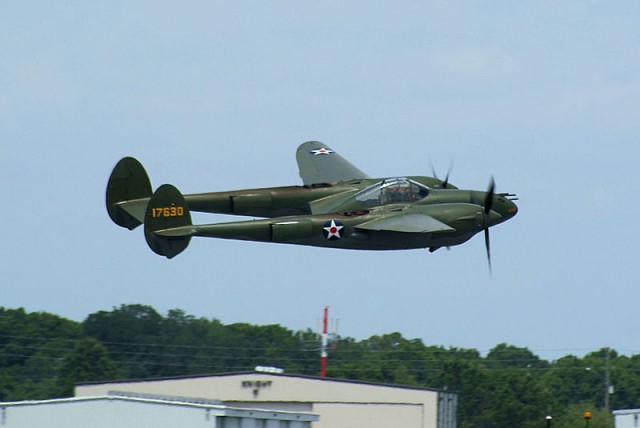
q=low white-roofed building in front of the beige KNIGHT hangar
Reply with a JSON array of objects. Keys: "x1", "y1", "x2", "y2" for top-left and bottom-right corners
[{"x1": 0, "y1": 394, "x2": 318, "y2": 428}]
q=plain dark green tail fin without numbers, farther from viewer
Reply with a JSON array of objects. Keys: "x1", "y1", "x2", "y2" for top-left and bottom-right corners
[{"x1": 106, "y1": 157, "x2": 153, "y2": 230}]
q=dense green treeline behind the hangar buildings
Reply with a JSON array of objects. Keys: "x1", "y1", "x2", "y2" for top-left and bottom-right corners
[{"x1": 0, "y1": 305, "x2": 640, "y2": 428}]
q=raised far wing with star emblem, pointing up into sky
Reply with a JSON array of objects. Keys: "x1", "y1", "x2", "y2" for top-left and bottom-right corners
[{"x1": 296, "y1": 141, "x2": 369, "y2": 185}]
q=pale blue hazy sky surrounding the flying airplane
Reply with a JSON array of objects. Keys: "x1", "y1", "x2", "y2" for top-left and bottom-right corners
[{"x1": 0, "y1": 0, "x2": 640, "y2": 360}]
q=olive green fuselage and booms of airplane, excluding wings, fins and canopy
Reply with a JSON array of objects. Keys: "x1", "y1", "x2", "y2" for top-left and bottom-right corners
[{"x1": 162, "y1": 177, "x2": 517, "y2": 250}]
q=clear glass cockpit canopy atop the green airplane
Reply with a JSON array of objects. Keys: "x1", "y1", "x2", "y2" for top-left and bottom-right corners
[{"x1": 355, "y1": 177, "x2": 430, "y2": 207}]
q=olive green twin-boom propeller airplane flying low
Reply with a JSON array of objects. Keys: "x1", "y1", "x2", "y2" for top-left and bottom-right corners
[{"x1": 106, "y1": 141, "x2": 518, "y2": 268}]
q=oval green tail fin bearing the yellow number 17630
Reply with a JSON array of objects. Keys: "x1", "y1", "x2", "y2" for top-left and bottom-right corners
[{"x1": 144, "y1": 184, "x2": 194, "y2": 259}]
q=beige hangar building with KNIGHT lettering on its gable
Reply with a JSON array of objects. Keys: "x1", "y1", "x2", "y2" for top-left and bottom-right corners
[{"x1": 76, "y1": 372, "x2": 457, "y2": 428}]
